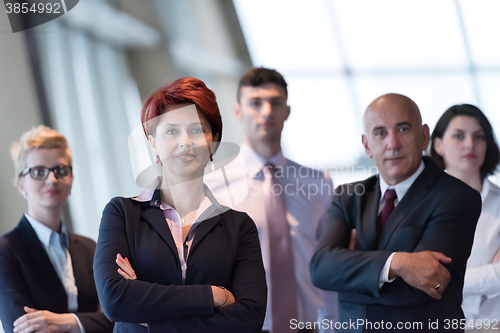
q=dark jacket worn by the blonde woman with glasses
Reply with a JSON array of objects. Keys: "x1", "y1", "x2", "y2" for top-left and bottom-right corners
[{"x1": 0, "y1": 216, "x2": 113, "y2": 333}]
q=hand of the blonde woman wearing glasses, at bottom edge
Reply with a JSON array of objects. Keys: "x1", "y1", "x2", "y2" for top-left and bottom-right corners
[{"x1": 14, "y1": 306, "x2": 80, "y2": 333}]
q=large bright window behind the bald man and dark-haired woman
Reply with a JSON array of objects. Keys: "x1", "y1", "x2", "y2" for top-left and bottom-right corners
[{"x1": 233, "y1": 0, "x2": 500, "y2": 184}]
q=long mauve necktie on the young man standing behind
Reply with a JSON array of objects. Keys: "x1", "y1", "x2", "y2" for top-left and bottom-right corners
[{"x1": 263, "y1": 163, "x2": 298, "y2": 333}]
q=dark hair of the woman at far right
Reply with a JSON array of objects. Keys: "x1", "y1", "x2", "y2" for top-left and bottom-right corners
[{"x1": 431, "y1": 104, "x2": 500, "y2": 180}]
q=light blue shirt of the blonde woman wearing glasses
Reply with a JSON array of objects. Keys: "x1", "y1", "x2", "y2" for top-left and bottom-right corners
[{"x1": 24, "y1": 213, "x2": 85, "y2": 333}]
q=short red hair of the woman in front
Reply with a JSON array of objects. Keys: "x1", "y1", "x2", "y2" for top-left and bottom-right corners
[{"x1": 141, "y1": 77, "x2": 222, "y2": 142}]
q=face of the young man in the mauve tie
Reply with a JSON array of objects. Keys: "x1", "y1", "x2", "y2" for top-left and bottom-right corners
[{"x1": 234, "y1": 83, "x2": 290, "y2": 143}]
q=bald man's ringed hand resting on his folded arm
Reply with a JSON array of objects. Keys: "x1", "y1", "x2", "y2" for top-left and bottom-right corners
[{"x1": 389, "y1": 251, "x2": 451, "y2": 299}]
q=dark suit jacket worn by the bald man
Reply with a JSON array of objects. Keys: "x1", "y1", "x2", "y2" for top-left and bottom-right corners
[{"x1": 310, "y1": 157, "x2": 481, "y2": 332}]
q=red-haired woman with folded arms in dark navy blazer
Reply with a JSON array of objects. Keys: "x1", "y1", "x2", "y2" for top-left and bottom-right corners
[{"x1": 94, "y1": 78, "x2": 267, "y2": 333}]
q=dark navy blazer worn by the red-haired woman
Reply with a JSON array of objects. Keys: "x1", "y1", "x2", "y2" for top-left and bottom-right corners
[{"x1": 94, "y1": 190, "x2": 267, "y2": 333}]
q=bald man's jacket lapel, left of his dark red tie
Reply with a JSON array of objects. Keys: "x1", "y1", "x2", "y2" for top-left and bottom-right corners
[{"x1": 356, "y1": 177, "x2": 380, "y2": 250}]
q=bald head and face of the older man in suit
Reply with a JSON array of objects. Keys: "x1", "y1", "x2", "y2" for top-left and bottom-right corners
[{"x1": 362, "y1": 94, "x2": 429, "y2": 186}]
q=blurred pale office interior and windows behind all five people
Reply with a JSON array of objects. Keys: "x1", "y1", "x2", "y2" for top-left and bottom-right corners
[{"x1": 0, "y1": 0, "x2": 500, "y2": 244}]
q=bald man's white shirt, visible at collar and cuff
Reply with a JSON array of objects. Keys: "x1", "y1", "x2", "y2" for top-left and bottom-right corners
[{"x1": 378, "y1": 162, "x2": 425, "y2": 288}]
